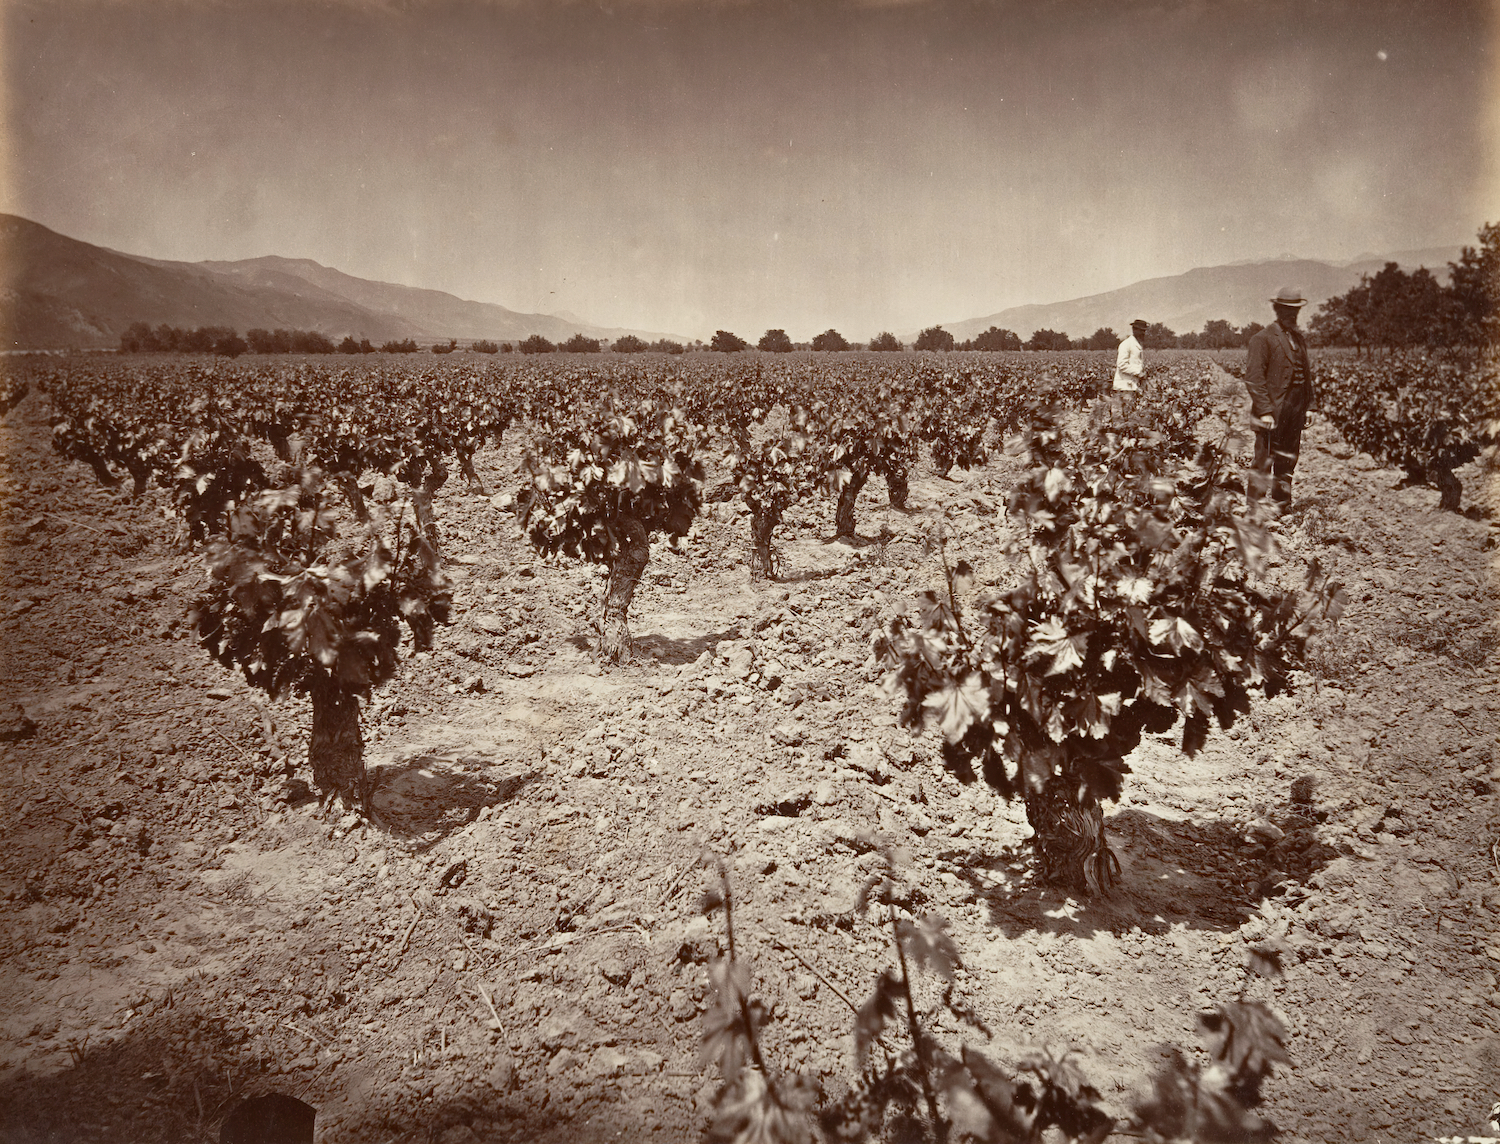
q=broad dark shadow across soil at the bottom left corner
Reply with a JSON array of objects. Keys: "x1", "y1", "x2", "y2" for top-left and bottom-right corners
[{"x1": 0, "y1": 1009, "x2": 663, "y2": 1144}]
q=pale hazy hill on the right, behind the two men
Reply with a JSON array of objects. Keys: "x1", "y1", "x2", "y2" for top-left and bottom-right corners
[{"x1": 936, "y1": 246, "x2": 1461, "y2": 342}]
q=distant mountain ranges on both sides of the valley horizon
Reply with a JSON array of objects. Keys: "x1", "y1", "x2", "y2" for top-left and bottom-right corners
[{"x1": 0, "y1": 214, "x2": 1460, "y2": 349}]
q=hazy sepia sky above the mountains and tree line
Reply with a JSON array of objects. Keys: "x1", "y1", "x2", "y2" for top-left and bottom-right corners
[{"x1": 0, "y1": 0, "x2": 1500, "y2": 340}]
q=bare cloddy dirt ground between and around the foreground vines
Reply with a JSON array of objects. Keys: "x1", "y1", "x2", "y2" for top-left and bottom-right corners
[{"x1": 0, "y1": 382, "x2": 1500, "y2": 1144}]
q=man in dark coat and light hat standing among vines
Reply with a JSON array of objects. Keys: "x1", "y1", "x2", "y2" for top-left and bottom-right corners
[{"x1": 1245, "y1": 286, "x2": 1313, "y2": 508}]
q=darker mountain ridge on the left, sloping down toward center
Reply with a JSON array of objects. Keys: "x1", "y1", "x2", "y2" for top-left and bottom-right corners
[{"x1": 0, "y1": 214, "x2": 684, "y2": 349}]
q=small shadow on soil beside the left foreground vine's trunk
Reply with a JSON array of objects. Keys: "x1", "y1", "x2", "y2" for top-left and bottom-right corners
[{"x1": 371, "y1": 754, "x2": 542, "y2": 850}]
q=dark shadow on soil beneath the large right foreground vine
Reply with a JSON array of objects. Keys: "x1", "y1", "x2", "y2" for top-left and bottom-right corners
[{"x1": 960, "y1": 810, "x2": 1338, "y2": 937}]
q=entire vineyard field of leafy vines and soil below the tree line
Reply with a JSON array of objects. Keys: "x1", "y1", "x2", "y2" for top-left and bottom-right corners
[{"x1": 0, "y1": 351, "x2": 1500, "y2": 1141}]
